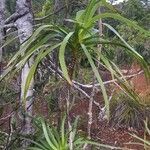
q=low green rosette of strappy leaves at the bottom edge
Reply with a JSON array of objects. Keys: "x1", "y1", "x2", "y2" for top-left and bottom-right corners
[{"x1": 24, "y1": 117, "x2": 121, "y2": 150}]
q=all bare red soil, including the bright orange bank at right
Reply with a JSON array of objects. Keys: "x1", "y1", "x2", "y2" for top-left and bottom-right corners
[{"x1": 0, "y1": 64, "x2": 150, "y2": 150}]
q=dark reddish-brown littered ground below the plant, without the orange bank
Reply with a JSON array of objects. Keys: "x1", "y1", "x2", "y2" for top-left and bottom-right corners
[{"x1": 36, "y1": 94, "x2": 149, "y2": 150}]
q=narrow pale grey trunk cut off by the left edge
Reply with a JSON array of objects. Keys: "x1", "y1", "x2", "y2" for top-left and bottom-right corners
[{"x1": 0, "y1": 0, "x2": 5, "y2": 75}]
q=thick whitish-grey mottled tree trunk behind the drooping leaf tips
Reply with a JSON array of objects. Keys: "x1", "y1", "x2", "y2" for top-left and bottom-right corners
[{"x1": 15, "y1": 0, "x2": 34, "y2": 146}]
